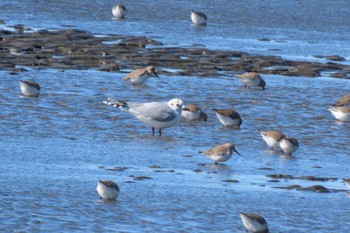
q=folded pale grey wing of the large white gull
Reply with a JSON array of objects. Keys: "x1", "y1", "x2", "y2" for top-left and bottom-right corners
[{"x1": 129, "y1": 102, "x2": 177, "y2": 122}]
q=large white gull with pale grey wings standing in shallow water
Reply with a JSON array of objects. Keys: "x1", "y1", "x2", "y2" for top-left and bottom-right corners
[{"x1": 103, "y1": 98, "x2": 183, "y2": 135}]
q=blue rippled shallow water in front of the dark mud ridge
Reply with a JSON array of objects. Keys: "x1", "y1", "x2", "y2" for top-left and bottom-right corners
[{"x1": 0, "y1": 70, "x2": 350, "y2": 232}]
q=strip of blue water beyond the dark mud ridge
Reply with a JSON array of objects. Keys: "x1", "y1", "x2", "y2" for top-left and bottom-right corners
[{"x1": 0, "y1": 0, "x2": 350, "y2": 59}]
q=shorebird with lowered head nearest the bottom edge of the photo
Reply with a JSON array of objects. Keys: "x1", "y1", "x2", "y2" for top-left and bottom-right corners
[{"x1": 239, "y1": 212, "x2": 269, "y2": 233}]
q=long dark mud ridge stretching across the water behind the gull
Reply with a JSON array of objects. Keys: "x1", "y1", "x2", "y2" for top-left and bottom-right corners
[{"x1": 0, "y1": 25, "x2": 350, "y2": 78}]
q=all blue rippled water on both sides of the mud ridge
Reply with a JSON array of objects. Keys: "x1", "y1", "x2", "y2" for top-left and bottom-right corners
[{"x1": 0, "y1": 0, "x2": 350, "y2": 232}]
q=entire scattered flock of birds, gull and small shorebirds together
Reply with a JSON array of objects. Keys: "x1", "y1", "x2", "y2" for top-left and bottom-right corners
[{"x1": 15, "y1": 4, "x2": 350, "y2": 233}]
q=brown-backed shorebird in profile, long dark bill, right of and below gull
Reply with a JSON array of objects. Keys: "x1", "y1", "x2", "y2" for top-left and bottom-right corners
[{"x1": 199, "y1": 143, "x2": 241, "y2": 164}]
